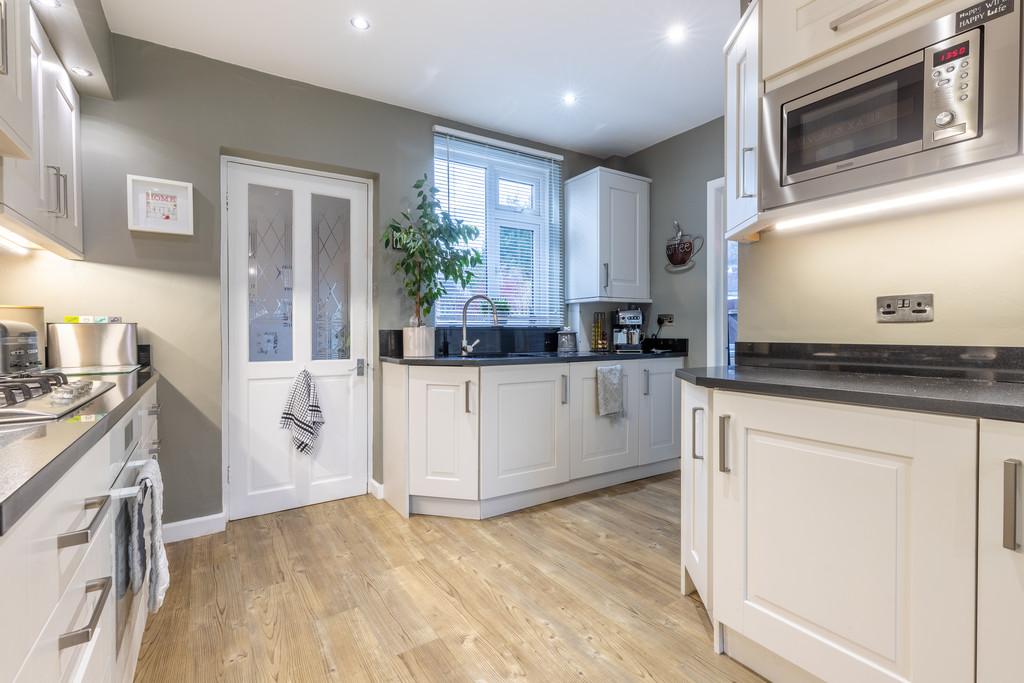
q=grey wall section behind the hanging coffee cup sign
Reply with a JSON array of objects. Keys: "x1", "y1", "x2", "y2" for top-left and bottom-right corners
[{"x1": 625, "y1": 119, "x2": 725, "y2": 367}]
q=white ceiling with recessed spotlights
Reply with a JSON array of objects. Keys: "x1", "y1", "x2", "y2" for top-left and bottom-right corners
[{"x1": 102, "y1": 0, "x2": 739, "y2": 158}]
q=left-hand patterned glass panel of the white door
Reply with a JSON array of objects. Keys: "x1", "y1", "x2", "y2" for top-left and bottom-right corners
[{"x1": 249, "y1": 184, "x2": 293, "y2": 362}]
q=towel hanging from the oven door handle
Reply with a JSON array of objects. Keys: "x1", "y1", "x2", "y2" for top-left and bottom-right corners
[{"x1": 129, "y1": 460, "x2": 171, "y2": 612}]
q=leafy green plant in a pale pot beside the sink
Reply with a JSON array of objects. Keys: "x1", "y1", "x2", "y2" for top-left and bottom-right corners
[{"x1": 383, "y1": 175, "x2": 483, "y2": 358}]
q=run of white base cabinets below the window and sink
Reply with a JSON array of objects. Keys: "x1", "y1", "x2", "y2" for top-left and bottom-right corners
[{"x1": 383, "y1": 357, "x2": 682, "y2": 518}]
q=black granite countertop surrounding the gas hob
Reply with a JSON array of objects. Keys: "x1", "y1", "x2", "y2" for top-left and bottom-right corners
[{"x1": 0, "y1": 368, "x2": 160, "y2": 536}]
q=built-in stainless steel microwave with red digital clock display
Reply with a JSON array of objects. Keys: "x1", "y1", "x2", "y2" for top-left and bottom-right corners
[{"x1": 759, "y1": 0, "x2": 1022, "y2": 210}]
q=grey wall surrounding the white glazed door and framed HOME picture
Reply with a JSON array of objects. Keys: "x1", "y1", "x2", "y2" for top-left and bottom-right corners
[{"x1": 0, "y1": 36, "x2": 598, "y2": 521}]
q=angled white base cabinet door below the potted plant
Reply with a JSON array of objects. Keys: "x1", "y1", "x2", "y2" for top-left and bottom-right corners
[{"x1": 409, "y1": 367, "x2": 480, "y2": 501}]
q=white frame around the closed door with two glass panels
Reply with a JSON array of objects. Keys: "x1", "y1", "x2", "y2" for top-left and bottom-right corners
[{"x1": 220, "y1": 155, "x2": 377, "y2": 523}]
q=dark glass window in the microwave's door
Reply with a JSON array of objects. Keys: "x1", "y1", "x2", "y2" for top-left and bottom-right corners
[{"x1": 785, "y1": 63, "x2": 924, "y2": 177}]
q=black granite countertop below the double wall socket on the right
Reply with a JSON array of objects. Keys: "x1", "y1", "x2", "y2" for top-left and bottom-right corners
[{"x1": 676, "y1": 366, "x2": 1024, "y2": 422}]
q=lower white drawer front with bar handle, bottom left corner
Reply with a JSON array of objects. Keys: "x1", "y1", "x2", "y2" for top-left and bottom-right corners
[{"x1": 15, "y1": 511, "x2": 116, "y2": 683}]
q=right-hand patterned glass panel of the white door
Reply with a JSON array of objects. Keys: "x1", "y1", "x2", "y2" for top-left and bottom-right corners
[{"x1": 312, "y1": 195, "x2": 352, "y2": 360}]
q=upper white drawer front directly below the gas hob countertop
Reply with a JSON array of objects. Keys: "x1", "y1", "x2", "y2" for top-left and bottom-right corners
[{"x1": 0, "y1": 435, "x2": 113, "y2": 681}]
